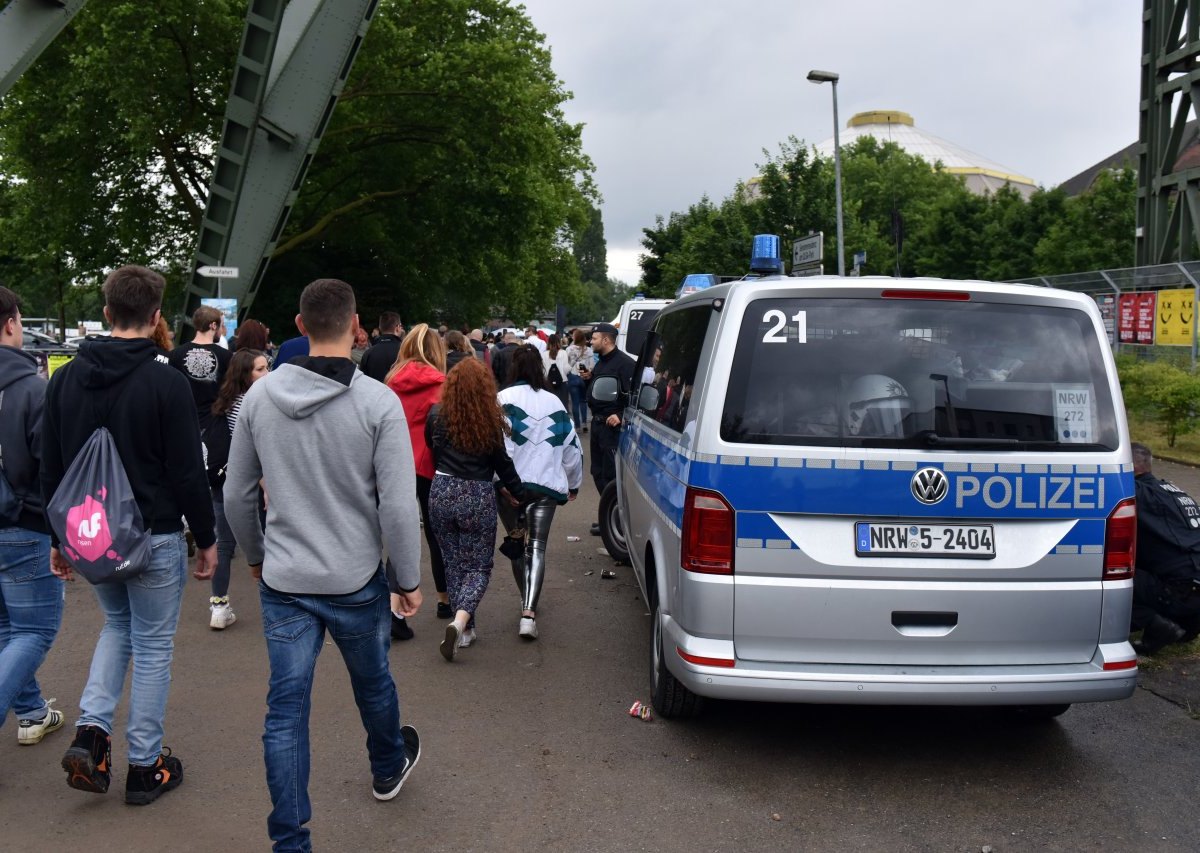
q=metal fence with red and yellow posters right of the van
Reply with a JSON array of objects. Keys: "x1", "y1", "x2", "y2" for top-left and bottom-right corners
[{"x1": 1016, "y1": 260, "x2": 1200, "y2": 368}]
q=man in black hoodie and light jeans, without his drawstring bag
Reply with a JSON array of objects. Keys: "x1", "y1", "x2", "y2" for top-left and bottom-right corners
[{"x1": 42, "y1": 266, "x2": 216, "y2": 805}]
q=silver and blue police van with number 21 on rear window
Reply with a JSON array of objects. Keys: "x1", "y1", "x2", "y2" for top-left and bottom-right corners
[{"x1": 592, "y1": 243, "x2": 1138, "y2": 717}]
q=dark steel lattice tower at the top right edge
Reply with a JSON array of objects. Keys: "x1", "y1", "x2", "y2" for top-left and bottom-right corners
[{"x1": 1136, "y1": 0, "x2": 1200, "y2": 266}]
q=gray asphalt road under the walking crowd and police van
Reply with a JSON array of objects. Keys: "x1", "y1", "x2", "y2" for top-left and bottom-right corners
[{"x1": 0, "y1": 453, "x2": 1200, "y2": 852}]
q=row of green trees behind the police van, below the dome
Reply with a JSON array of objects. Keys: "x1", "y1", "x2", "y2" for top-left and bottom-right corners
[{"x1": 641, "y1": 137, "x2": 1136, "y2": 290}]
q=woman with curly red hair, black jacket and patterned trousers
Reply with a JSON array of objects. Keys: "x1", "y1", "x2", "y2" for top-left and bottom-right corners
[{"x1": 425, "y1": 359, "x2": 523, "y2": 661}]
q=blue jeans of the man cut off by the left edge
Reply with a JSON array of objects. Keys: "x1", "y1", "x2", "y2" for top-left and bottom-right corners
[{"x1": 0, "y1": 527, "x2": 62, "y2": 725}]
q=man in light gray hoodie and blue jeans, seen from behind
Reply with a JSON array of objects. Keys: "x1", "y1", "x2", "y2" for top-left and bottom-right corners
[{"x1": 224, "y1": 278, "x2": 421, "y2": 851}]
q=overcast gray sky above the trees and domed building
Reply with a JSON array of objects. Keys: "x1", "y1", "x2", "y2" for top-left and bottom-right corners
[{"x1": 523, "y1": 0, "x2": 1141, "y2": 283}]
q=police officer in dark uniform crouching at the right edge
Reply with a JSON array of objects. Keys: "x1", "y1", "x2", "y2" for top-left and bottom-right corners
[{"x1": 1132, "y1": 444, "x2": 1200, "y2": 655}]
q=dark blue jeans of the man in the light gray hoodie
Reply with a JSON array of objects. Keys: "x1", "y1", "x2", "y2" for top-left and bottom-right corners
[{"x1": 258, "y1": 566, "x2": 404, "y2": 851}]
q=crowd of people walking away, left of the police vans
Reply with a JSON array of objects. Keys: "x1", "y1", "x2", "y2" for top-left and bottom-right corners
[{"x1": 0, "y1": 272, "x2": 592, "y2": 851}]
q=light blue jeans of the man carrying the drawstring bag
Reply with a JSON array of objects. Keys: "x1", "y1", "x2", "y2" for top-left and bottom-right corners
[{"x1": 76, "y1": 533, "x2": 187, "y2": 764}]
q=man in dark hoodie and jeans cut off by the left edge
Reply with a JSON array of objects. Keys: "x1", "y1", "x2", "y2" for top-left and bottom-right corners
[{"x1": 0, "y1": 287, "x2": 64, "y2": 744}]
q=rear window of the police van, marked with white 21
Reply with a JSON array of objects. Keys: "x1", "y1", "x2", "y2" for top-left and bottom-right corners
[{"x1": 721, "y1": 298, "x2": 1117, "y2": 451}]
